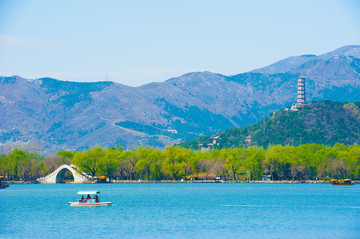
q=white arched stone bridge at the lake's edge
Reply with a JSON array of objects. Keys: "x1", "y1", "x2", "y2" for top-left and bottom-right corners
[{"x1": 36, "y1": 164, "x2": 90, "y2": 183}]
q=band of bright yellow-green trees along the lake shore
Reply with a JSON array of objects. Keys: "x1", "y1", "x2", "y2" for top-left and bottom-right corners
[{"x1": 0, "y1": 143, "x2": 360, "y2": 181}]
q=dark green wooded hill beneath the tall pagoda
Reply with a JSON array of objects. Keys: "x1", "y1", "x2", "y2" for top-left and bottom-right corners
[{"x1": 181, "y1": 101, "x2": 360, "y2": 149}]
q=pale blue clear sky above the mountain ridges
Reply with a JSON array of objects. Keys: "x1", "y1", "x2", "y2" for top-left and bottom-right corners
[{"x1": 0, "y1": 0, "x2": 360, "y2": 86}]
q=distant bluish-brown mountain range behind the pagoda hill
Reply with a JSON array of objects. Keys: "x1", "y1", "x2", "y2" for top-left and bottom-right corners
[{"x1": 0, "y1": 46, "x2": 360, "y2": 153}]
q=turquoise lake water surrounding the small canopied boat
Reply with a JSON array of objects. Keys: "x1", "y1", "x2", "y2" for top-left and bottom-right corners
[{"x1": 0, "y1": 183, "x2": 360, "y2": 239}]
